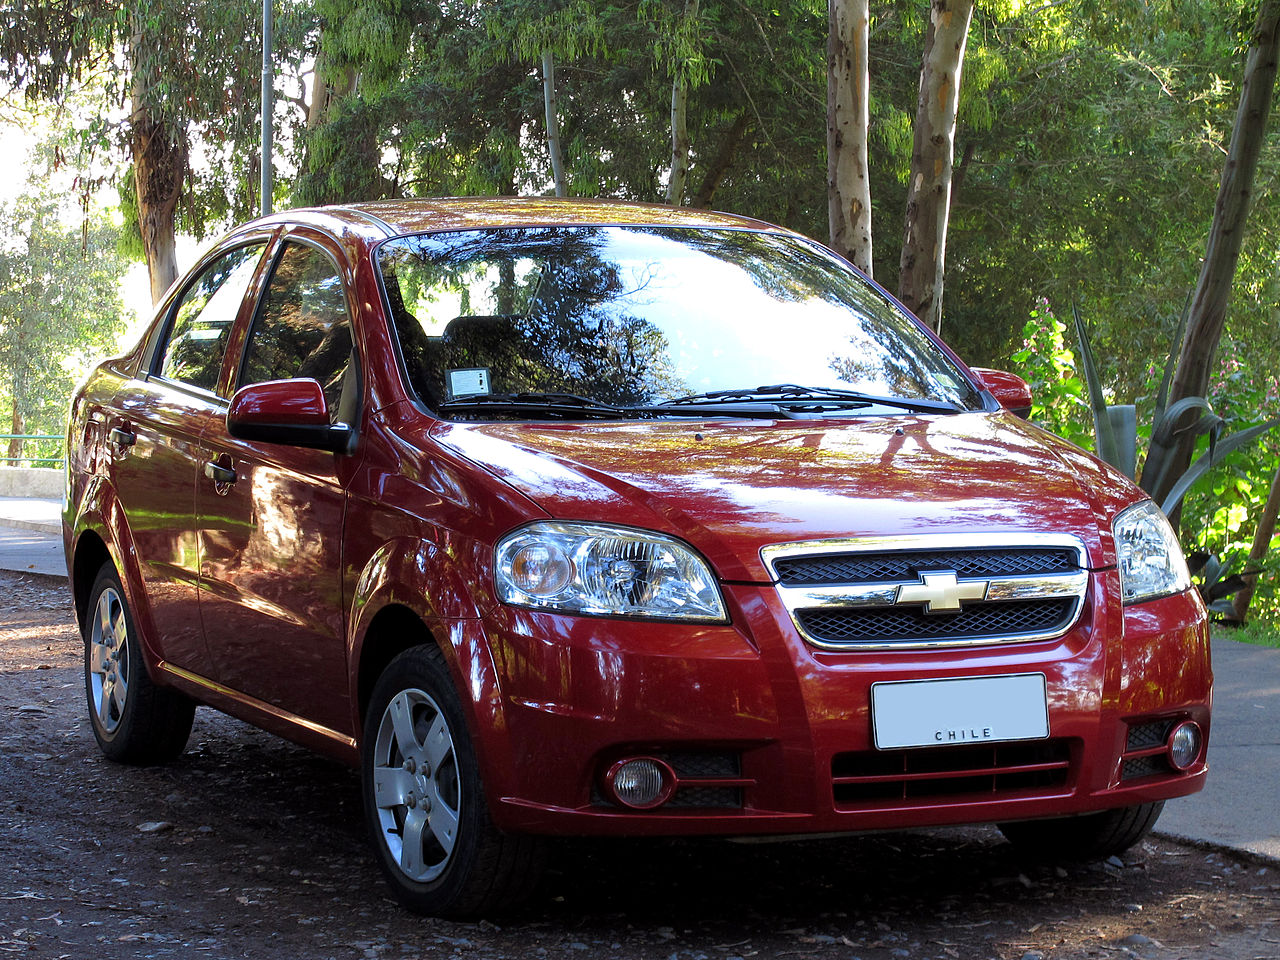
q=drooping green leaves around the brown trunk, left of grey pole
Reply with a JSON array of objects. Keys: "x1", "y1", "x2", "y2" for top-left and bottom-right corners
[{"x1": 0, "y1": 0, "x2": 312, "y2": 237}]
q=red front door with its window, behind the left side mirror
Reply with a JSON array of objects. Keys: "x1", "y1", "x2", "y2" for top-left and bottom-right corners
[{"x1": 196, "y1": 232, "x2": 361, "y2": 736}]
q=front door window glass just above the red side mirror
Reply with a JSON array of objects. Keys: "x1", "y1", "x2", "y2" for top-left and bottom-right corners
[{"x1": 241, "y1": 243, "x2": 353, "y2": 419}]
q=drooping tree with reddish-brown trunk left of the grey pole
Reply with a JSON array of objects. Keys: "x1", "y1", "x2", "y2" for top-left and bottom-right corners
[{"x1": 0, "y1": 0, "x2": 309, "y2": 301}]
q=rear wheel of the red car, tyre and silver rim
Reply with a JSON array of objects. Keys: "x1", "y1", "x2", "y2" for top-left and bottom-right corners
[{"x1": 81, "y1": 563, "x2": 196, "y2": 765}]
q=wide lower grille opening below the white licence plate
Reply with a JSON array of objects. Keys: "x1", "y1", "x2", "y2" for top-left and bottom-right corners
[{"x1": 831, "y1": 740, "x2": 1071, "y2": 808}]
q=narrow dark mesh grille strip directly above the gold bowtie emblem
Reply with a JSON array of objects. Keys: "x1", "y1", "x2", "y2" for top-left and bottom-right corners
[{"x1": 773, "y1": 548, "x2": 1080, "y2": 585}]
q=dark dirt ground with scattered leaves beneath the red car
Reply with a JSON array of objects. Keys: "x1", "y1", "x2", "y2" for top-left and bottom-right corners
[{"x1": 0, "y1": 573, "x2": 1280, "y2": 960}]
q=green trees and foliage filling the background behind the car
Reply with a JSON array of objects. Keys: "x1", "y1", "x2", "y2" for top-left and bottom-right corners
[{"x1": 0, "y1": 0, "x2": 1280, "y2": 620}]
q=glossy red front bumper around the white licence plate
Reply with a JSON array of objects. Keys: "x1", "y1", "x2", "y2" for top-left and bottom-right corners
[{"x1": 454, "y1": 571, "x2": 1212, "y2": 836}]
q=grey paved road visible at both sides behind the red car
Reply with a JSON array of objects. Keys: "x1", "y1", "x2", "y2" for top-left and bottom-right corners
[{"x1": 0, "y1": 497, "x2": 1280, "y2": 860}]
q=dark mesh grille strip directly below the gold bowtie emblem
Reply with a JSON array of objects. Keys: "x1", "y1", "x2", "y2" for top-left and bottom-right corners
[{"x1": 799, "y1": 600, "x2": 1075, "y2": 644}]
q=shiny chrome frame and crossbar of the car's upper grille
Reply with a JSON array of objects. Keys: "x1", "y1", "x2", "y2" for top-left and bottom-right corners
[{"x1": 760, "y1": 534, "x2": 1089, "y2": 650}]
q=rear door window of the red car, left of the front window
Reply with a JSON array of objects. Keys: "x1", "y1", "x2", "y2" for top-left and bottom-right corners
[{"x1": 160, "y1": 243, "x2": 264, "y2": 392}]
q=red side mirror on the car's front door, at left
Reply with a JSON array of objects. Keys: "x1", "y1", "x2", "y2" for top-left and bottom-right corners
[{"x1": 227, "y1": 378, "x2": 353, "y2": 453}]
